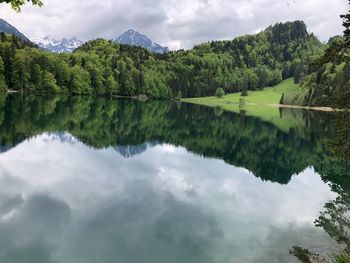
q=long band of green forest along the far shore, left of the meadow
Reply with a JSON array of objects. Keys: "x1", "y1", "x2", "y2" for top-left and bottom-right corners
[{"x1": 0, "y1": 21, "x2": 322, "y2": 98}]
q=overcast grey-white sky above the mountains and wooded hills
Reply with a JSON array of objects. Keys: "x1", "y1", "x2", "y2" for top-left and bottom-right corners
[{"x1": 0, "y1": 0, "x2": 348, "y2": 49}]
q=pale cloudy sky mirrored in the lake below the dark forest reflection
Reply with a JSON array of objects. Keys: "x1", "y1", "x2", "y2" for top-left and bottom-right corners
[{"x1": 0, "y1": 136, "x2": 334, "y2": 263}]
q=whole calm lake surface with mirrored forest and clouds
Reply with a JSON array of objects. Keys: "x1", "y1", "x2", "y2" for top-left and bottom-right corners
[{"x1": 0, "y1": 95, "x2": 350, "y2": 263}]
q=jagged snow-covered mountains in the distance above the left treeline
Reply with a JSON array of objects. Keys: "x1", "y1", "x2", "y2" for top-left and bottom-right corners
[{"x1": 31, "y1": 36, "x2": 83, "y2": 53}]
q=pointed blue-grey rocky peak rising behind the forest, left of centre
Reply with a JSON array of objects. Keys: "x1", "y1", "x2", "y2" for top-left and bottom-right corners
[{"x1": 113, "y1": 29, "x2": 169, "y2": 53}]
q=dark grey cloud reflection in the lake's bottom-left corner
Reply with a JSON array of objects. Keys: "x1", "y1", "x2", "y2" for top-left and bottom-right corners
[{"x1": 0, "y1": 194, "x2": 70, "y2": 263}]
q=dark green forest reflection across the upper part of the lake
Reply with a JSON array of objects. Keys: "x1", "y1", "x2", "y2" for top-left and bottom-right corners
[{"x1": 0, "y1": 95, "x2": 350, "y2": 262}]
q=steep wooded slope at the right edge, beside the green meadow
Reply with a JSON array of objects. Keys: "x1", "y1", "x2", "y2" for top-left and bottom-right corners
[{"x1": 283, "y1": 1, "x2": 350, "y2": 108}]
